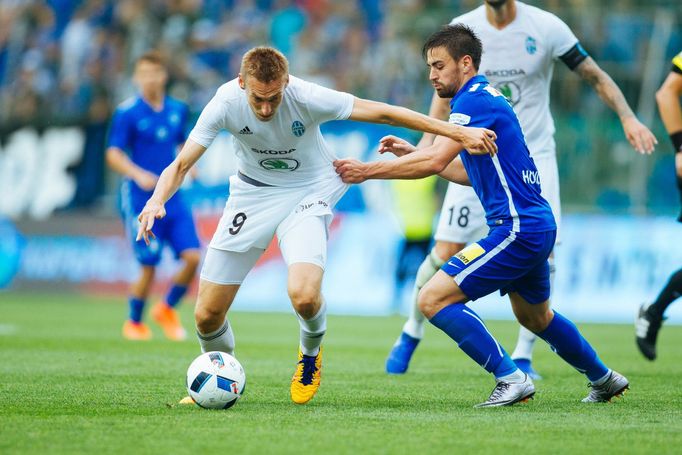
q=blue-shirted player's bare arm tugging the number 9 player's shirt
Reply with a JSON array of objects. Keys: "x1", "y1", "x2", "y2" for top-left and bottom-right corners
[{"x1": 334, "y1": 137, "x2": 463, "y2": 183}]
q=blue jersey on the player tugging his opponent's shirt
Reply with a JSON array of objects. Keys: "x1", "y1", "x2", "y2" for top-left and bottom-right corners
[{"x1": 450, "y1": 75, "x2": 556, "y2": 232}]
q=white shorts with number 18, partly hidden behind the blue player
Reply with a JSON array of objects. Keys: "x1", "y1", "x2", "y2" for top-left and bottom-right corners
[{"x1": 434, "y1": 154, "x2": 561, "y2": 244}]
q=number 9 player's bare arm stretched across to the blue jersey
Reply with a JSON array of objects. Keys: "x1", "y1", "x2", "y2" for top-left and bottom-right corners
[{"x1": 349, "y1": 98, "x2": 497, "y2": 154}]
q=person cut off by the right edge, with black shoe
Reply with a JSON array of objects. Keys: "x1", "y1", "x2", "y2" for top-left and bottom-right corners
[{"x1": 635, "y1": 52, "x2": 682, "y2": 360}]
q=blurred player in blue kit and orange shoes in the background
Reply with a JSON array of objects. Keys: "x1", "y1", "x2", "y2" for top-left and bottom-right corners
[{"x1": 106, "y1": 51, "x2": 201, "y2": 341}]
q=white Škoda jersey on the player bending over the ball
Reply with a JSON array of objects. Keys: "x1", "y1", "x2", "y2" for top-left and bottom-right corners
[{"x1": 189, "y1": 76, "x2": 354, "y2": 187}]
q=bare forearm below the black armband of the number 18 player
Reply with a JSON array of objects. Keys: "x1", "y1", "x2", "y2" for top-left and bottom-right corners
[{"x1": 576, "y1": 57, "x2": 658, "y2": 154}]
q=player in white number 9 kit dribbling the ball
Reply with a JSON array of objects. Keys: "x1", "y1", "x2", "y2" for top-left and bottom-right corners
[{"x1": 138, "y1": 47, "x2": 496, "y2": 404}]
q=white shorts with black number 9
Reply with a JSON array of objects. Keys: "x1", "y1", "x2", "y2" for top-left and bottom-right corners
[{"x1": 201, "y1": 176, "x2": 348, "y2": 284}]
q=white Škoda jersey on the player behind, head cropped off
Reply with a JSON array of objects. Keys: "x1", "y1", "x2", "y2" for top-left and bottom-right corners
[{"x1": 451, "y1": 1, "x2": 578, "y2": 157}]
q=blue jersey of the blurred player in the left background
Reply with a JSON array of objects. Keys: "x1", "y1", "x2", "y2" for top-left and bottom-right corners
[{"x1": 108, "y1": 96, "x2": 189, "y2": 213}]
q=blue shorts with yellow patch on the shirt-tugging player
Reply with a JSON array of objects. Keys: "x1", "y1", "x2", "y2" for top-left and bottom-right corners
[{"x1": 441, "y1": 228, "x2": 556, "y2": 304}]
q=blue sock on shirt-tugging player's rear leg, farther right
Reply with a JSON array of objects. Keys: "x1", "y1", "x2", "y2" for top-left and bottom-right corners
[{"x1": 536, "y1": 311, "x2": 609, "y2": 382}]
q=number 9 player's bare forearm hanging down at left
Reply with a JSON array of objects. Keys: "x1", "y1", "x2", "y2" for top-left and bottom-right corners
[{"x1": 137, "y1": 139, "x2": 206, "y2": 245}]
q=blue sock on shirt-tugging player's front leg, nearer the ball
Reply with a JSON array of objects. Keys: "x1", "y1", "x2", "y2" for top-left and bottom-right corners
[{"x1": 430, "y1": 303, "x2": 517, "y2": 378}]
